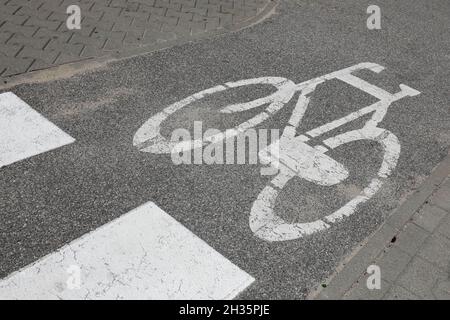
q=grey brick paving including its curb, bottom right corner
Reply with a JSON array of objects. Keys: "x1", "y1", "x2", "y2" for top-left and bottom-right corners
[{"x1": 309, "y1": 151, "x2": 450, "y2": 300}]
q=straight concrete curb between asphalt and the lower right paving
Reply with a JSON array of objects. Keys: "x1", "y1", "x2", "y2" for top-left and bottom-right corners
[{"x1": 308, "y1": 153, "x2": 450, "y2": 300}]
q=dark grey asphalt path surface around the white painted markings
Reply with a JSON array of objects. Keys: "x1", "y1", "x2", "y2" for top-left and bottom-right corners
[{"x1": 0, "y1": 0, "x2": 450, "y2": 299}]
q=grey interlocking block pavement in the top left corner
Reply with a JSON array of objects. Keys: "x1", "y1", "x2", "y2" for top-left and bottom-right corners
[{"x1": 0, "y1": 0, "x2": 275, "y2": 77}]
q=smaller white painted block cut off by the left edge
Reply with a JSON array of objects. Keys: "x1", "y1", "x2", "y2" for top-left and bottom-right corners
[{"x1": 0, "y1": 92, "x2": 75, "y2": 168}]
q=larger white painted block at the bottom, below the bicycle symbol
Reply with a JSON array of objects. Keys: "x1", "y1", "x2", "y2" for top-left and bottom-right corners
[{"x1": 0, "y1": 202, "x2": 254, "y2": 299}]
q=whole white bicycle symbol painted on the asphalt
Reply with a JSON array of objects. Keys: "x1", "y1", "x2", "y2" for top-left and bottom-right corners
[{"x1": 133, "y1": 63, "x2": 420, "y2": 241}]
